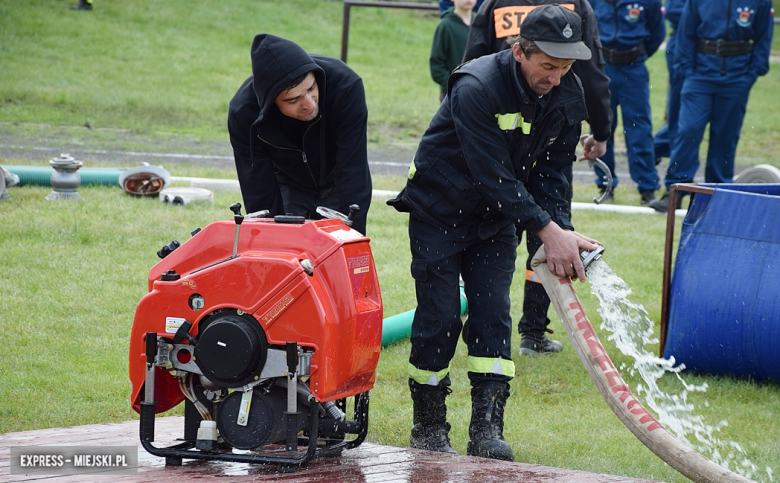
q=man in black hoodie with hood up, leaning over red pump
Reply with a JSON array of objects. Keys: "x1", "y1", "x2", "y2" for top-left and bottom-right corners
[{"x1": 228, "y1": 34, "x2": 371, "y2": 234}]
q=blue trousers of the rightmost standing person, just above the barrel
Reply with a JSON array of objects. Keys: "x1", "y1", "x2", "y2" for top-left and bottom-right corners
[{"x1": 664, "y1": 77, "x2": 755, "y2": 189}]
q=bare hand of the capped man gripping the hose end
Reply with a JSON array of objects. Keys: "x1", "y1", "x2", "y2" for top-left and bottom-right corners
[{"x1": 536, "y1": 222, "x2": 601, "y2": 282}]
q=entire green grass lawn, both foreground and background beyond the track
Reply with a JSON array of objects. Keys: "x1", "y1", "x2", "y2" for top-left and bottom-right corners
[{"x1": 0, "y1": 0, "x2": 780, "y2": 482}]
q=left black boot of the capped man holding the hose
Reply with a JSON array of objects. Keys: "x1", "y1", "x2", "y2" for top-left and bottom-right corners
[{"x1": 409, "y1": 379, "x2": 458, "y2": 454}]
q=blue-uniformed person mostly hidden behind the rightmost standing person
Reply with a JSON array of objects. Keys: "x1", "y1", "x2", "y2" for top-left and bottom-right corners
[{"x1": 653, "y1": 0, "x2": 685, "y2": 165}]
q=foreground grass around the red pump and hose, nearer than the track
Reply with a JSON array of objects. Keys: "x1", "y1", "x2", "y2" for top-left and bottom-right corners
[{"x1": 0, "y1": 173, "x2": 780, "y2": 482}]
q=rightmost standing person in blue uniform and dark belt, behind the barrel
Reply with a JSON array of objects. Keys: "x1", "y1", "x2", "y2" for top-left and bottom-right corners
[{"x1": 650, "y1": 0, "x2": 774, "y2": 213}]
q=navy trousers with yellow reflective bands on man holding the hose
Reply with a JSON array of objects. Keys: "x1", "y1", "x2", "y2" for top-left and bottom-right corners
[{"x1": 409, "y1": 213, "x2": 517, "y2": 385}]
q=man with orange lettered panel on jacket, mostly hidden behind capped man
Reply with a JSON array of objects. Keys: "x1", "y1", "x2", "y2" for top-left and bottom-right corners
[{"x1": 463, "y1": 0, "x2": 612, "y2": 356}]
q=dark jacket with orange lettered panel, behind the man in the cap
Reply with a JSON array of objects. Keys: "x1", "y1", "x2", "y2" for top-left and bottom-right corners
[{"x1": 463, "y1": 0, "x2": 612, "y2": 141}]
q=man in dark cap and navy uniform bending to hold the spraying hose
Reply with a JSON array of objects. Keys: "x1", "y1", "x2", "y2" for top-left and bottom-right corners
[{"x1": 388, "y1": 5, "x2": 597, "y2": 460}]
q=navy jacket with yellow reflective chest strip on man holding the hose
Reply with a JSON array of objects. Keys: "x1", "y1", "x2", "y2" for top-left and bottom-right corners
[{"x1": 388, "y1": 50, "x2": 587, "y2": 239}]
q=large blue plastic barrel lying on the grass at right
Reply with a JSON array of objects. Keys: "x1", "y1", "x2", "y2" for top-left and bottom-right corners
[{"x1": 663, "y1": 184, "x2": 780, "y2": 382}]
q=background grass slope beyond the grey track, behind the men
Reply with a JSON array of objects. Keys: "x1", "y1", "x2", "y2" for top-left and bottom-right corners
[{"x1": 0, "y1": 0, "x2": 780, "y2": 167}]
